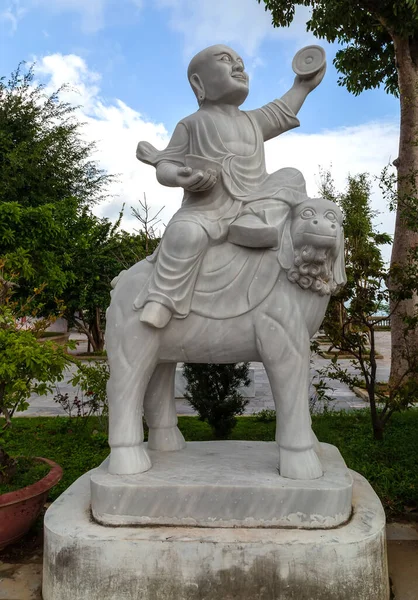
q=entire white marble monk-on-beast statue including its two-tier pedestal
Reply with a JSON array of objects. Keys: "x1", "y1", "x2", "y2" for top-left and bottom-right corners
[{"x1": 42, "y1": 45, "x2": 390, "y2": 600}]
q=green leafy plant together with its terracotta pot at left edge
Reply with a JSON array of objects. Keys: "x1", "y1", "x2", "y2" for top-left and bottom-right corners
[{"x1": 0, "y1": 263, "x2": 69, "y2": 549}]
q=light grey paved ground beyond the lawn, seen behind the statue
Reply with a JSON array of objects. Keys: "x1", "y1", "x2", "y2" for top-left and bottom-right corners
[{"x1": 21, "y1": 331, "x2": 390, "y2": 418}]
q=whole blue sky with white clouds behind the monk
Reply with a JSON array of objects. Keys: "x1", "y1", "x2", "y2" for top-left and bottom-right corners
[{"x1": 0, "y1": 0, "x2": 399, "y2": 246}]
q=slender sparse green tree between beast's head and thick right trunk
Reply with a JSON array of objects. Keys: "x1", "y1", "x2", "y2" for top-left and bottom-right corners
[{"x1": 321, "y1": 173, "x2": 418, "y2": 440}]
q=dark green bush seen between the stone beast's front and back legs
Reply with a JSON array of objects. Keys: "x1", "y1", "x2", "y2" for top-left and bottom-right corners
[{"x1": 183, "y1": 363, "x2": 250, "y2": 439}]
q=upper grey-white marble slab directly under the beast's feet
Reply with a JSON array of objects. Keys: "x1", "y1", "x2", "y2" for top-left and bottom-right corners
[{"x1": 91, "y1": 441, "x2": 353, "y2": 529}]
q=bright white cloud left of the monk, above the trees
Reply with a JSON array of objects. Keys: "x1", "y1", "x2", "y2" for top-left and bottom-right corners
[{"x1": 36, "y1": 54, "x2": 181, "y2": 230}]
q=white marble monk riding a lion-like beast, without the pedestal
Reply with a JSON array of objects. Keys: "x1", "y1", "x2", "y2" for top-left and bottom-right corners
[{"x1": 106, "y1": 45, "x2": 345, "y2": 480}]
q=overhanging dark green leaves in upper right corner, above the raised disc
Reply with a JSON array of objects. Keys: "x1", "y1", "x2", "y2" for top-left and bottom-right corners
[{"x1": 258, "y1": 0, "x2": 418, "y2": 95}]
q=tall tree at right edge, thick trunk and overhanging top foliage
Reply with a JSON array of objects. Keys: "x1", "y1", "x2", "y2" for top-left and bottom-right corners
[{"x1": 258, "y1": 0, "x2": 418, "y2": 385}]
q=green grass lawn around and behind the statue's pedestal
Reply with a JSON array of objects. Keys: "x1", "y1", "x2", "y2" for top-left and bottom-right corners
[{"x1": 2, "y1": 409, "x2": 418, "y2": 518}]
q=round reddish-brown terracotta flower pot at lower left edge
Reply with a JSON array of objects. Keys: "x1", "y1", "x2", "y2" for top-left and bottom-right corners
[{"x1": 0, "y1": 458, "x2": 62, "y2": 550}]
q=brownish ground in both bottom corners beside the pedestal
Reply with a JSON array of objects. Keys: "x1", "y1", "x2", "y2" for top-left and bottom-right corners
[{"x1": 0, "y1": 523, "x2": 418, "y2": 600}]
